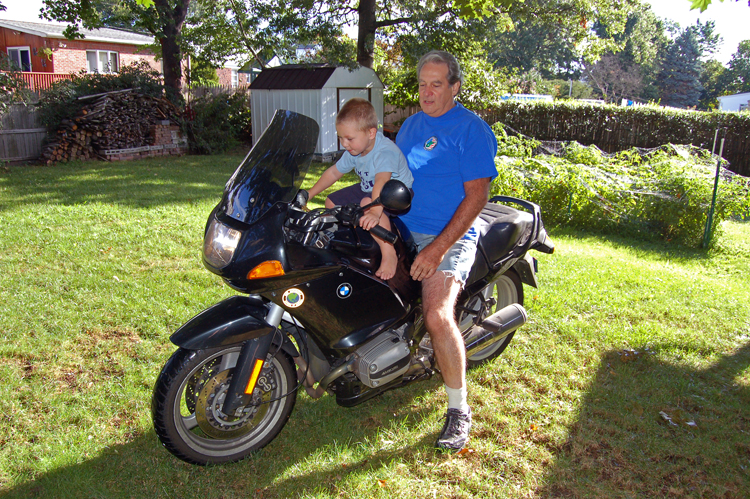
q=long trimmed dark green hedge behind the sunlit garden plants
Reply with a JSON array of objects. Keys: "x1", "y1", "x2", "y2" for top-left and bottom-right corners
[{"x1": 481, "y1": 101, "x2": 750, "y2": 176}]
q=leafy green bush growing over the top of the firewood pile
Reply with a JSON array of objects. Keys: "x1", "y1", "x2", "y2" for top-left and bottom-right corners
[{"x1": 37, "y1": 61, "x2": 164, "y2": 130}]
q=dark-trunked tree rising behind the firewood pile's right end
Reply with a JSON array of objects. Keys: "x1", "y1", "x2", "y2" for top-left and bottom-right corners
[{"x1": 42, "y1": 0, "x2": 190, "y2": 97}]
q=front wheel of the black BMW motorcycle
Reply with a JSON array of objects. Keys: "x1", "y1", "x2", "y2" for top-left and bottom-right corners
[{"x1": 151, "y1": 345, "x2": 297, "y2": 465}]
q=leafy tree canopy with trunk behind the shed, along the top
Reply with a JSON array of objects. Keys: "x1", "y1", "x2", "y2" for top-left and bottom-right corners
[{"x1": 185, "y1": 0, "x2": 637, "y2": 73}]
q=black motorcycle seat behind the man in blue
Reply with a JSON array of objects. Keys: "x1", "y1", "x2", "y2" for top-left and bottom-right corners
[{"x1": 477, "y1": 203, "x2": 534, "y2": 268}]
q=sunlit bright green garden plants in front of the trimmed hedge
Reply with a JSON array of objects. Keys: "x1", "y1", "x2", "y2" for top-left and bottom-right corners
[{"x1": 492, "y1": 133, "x2": 750, "y2": 247}]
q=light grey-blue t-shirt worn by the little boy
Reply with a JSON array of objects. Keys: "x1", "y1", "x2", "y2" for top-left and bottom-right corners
[{"x1": 336, "y1": 132, "x2": 414, "y2": 192}]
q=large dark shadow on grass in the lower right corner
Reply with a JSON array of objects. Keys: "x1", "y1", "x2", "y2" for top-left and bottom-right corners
[{"x1": 538, "y1": 344, "x2": 750, "y2": 498}]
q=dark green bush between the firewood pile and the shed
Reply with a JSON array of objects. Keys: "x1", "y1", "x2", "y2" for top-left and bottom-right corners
[{"x1": 184, "y1": 89, "x2": 251, "y2": 154}]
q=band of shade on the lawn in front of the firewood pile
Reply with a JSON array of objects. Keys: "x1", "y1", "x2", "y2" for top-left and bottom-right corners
[{"x1": 0, "y1": 156, "x2": 242, "y2": 211}]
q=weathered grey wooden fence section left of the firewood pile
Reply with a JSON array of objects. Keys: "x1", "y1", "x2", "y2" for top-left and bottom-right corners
[{"x1": 0, "y1": 106, "x2": 47, "y2": 161}]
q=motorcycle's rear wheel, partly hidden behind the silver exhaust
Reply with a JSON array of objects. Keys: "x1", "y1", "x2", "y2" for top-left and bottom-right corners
[{"x1": 458, "y1": 270, "x2": 523, "y2": 368}]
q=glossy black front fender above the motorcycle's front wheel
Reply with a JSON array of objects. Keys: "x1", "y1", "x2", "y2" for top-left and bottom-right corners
[{"x1": 169, "y1": 296, "x2": 276, "y2": 350}]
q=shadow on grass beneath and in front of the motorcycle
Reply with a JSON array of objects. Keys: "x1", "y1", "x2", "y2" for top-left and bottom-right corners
[{"x1": 3, "y1": 379, "x2": 438, "y2": 499}]
